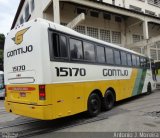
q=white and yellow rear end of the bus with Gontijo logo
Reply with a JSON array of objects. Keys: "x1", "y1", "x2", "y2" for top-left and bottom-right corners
[{"x1": 4, "y1": 20, "x2": 53, "y2": 120}]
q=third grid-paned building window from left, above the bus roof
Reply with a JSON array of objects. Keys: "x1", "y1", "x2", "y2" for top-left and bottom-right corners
[{"x1": 100, "y1": 29, "x2": 111, "y2": 42}]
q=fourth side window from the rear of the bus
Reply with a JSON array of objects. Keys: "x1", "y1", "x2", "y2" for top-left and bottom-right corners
[{"x1": 96, "y1": 46, "x2": 105, "y2": 63}]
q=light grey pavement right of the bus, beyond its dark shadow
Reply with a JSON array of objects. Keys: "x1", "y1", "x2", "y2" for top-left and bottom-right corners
[{"x1": 33, "y1": 90, "x2": 160, "y2": 138}]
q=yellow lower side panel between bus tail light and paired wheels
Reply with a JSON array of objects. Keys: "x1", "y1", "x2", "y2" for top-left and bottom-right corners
[{"x1": 48, "y1": 83, "x2": 85, "y2": 118}]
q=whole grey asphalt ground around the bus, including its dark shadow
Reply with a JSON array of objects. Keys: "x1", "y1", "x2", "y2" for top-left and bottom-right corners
[{"x1": 0, "y1": 90, "x2": 160, "y2": 138}]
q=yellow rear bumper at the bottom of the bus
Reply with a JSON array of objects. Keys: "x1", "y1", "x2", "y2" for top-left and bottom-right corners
[{"x1": 5, "y1": 101, "x2": 54, "y2": 120}]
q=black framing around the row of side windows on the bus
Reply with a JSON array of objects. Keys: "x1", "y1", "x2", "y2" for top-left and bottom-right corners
[{"x1": 48, "y1": 28, "x2": 149, "y2": 69}]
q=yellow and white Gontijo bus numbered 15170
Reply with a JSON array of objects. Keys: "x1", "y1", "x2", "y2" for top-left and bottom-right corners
[{"x1": 4, "y1": 19, "x2": 154, "y2": 120}]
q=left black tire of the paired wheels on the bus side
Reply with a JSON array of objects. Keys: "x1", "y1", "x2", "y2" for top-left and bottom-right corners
[{"x1": 87, "y1": 93, "x2": 101, "y2": 117}]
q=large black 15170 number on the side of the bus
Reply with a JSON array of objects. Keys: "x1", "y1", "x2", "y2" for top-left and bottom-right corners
[{"x1": 55, "y1": 67, "x2": 86, "y2": 77}]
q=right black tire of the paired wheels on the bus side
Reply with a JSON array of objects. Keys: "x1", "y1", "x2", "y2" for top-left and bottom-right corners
[{"x1": 102, "y1": 90, "x2": 115, "y2": 111}]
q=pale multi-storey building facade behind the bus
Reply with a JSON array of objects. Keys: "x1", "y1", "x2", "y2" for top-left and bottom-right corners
[{"x1": 12, "y1": 0, "x2": 160, "y2": 61}]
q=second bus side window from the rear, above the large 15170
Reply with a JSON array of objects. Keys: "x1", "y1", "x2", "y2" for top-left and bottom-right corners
[{"x1": 70, "y1": 39, "x2": 83, "y2": 59}]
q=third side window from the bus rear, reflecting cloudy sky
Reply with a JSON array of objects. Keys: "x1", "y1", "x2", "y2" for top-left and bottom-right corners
[{"x1": 83, "y1": 42, "x2": 95, "y2": 61}]
